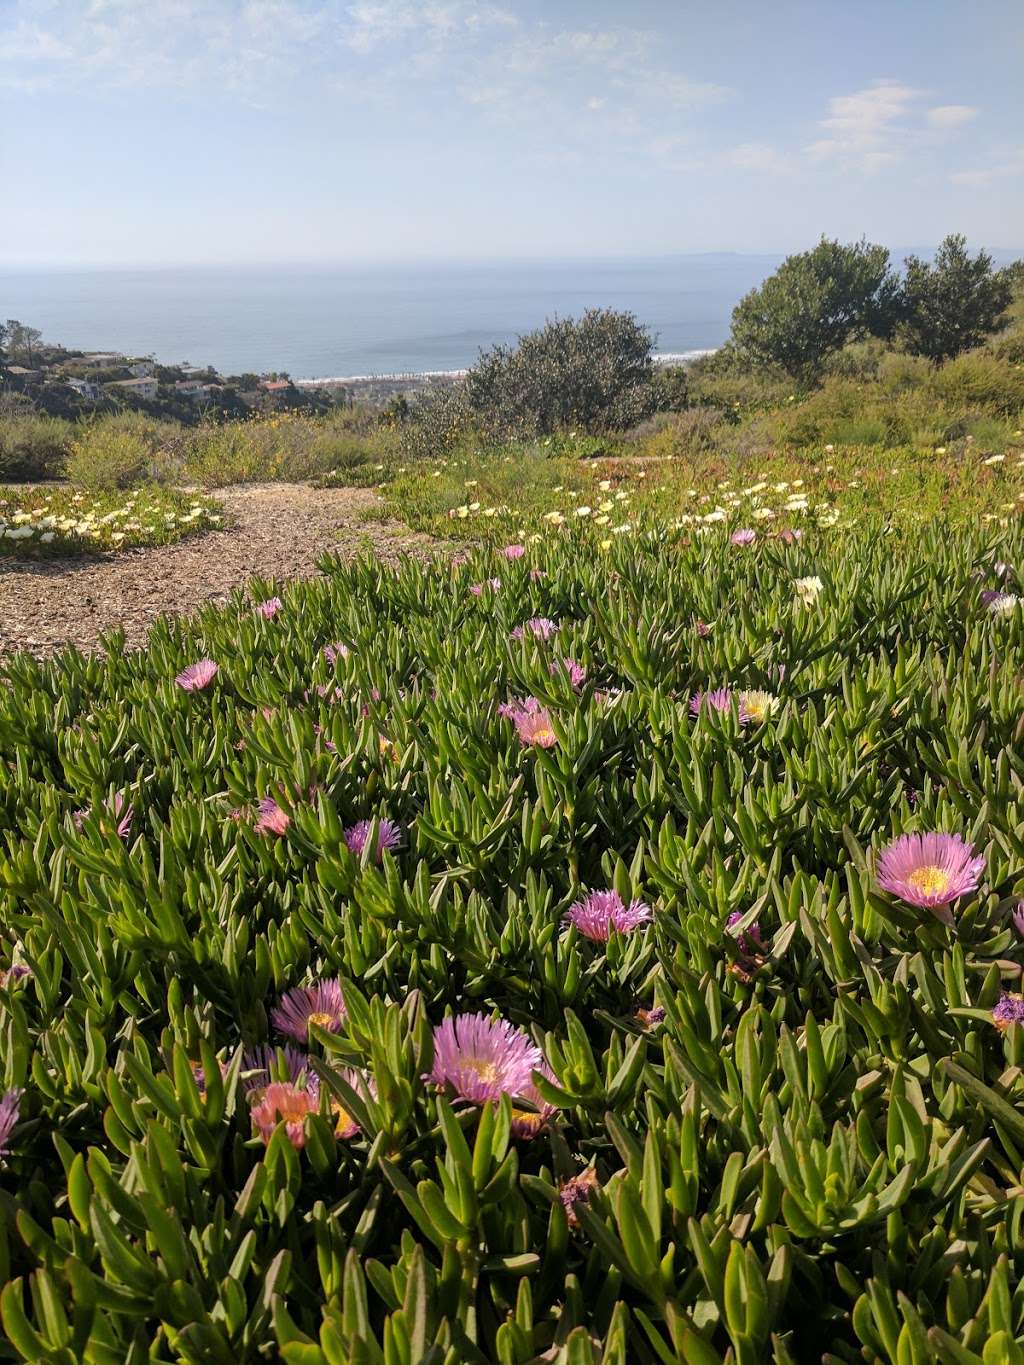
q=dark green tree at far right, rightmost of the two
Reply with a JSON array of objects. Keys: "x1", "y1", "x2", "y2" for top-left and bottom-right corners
[{"x1": 898, "y1": 233, "x2": 1014, "y2": 364}]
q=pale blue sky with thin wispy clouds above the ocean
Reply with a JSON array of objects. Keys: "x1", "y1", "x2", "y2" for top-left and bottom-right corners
[{"x1": 0, "y1": 0, "x2": 1024, "y2": 265}]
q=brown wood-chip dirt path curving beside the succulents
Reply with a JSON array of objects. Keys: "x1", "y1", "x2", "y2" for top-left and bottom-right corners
[{"x1": 0, "y1": 483, "x2": 430, "y2": 657}]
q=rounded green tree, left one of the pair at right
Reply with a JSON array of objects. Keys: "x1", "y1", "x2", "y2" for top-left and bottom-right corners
[{"x1": 732, "y1": 238, "x2": 898, "y2": 379}]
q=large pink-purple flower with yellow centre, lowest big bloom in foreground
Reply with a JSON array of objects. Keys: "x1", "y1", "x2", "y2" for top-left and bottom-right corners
[{"x1": 427, "y1": 1014, "x2": 545, "y2": 1104}]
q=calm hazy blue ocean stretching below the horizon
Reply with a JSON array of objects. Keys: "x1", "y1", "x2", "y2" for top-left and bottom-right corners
[{"x1": 0, "y1": 255, "x2": 780, "y2": 378}]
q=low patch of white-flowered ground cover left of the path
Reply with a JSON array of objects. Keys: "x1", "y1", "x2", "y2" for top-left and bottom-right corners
[{"x1": 0, "y1": 485, "x2": 221, "y2": 558}]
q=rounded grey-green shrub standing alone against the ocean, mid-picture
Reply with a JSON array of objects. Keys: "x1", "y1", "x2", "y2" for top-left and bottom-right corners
[{"x1": 466, "y1": 308, "x2": 658, "y2": 438}]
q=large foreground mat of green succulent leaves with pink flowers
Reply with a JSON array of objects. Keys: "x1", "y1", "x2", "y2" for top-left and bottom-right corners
[{"x1": 0, "y1": 517, "x2": 1024, "y2": 1365}]
